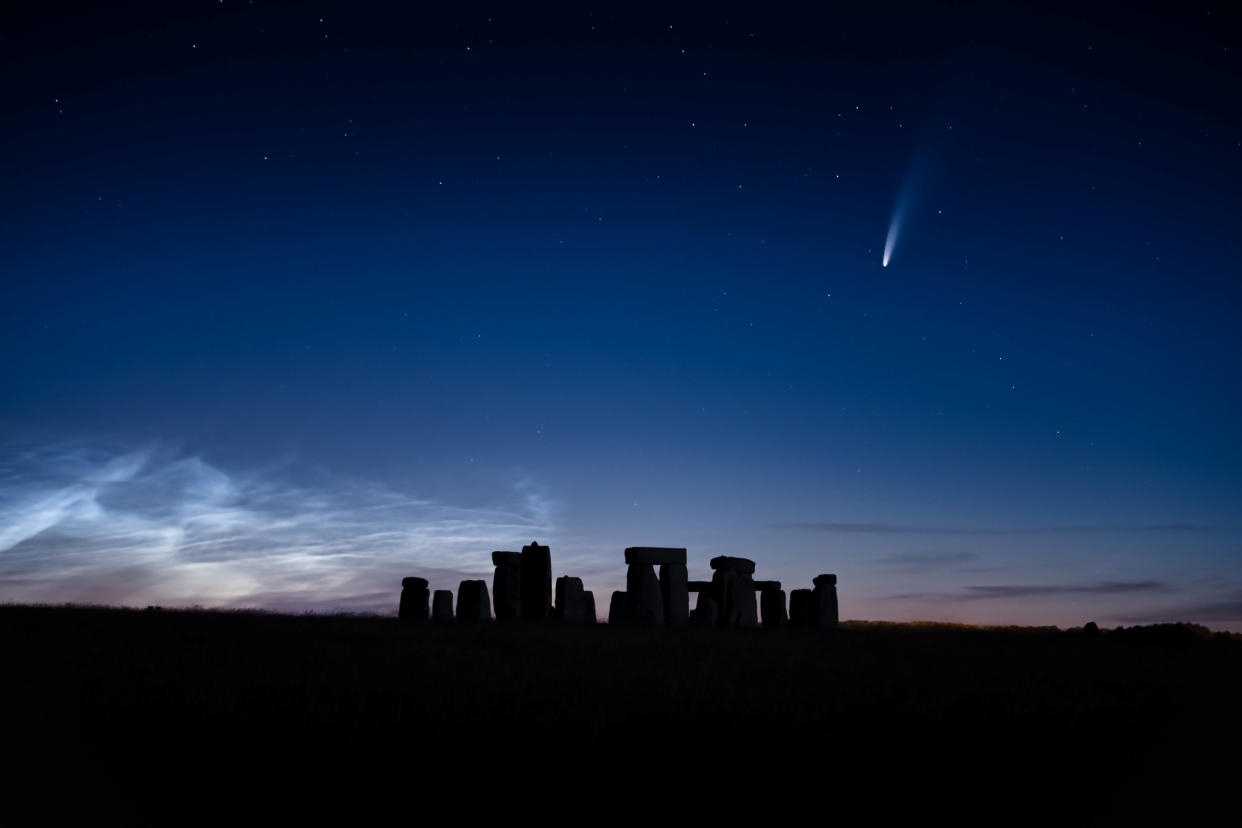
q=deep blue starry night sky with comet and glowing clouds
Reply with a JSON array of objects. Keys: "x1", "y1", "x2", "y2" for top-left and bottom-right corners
[{"x1": 0, "y1": 0, "x2": 1242, "y2": 629}]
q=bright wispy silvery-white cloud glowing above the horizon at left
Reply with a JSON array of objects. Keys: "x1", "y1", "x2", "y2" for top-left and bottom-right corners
[{"x1": 0, "y1": 446, "x2": 555, "y2": 610}]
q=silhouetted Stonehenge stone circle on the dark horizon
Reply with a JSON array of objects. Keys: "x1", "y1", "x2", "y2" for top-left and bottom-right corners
[{"x1": 397, "y1": 541, "x2": 840, "y2": 629}]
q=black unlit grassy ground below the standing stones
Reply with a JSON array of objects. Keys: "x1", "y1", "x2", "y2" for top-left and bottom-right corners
[{"x1": 0, "y1": 606, "x2": 1242, "y2": 824}]
